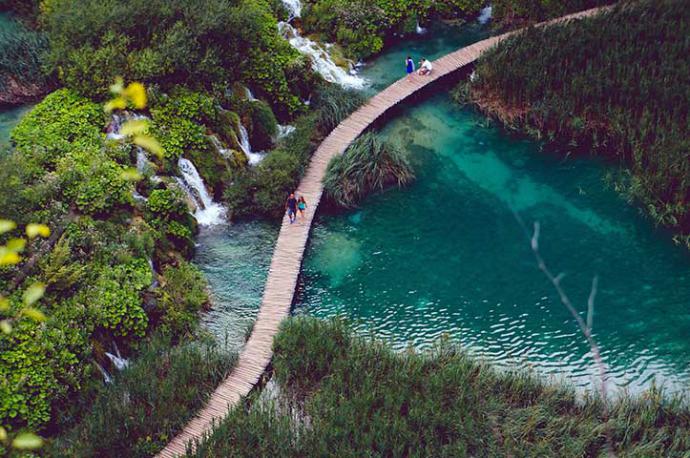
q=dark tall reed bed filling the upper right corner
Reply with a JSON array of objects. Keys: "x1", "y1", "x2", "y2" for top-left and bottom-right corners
[{"x1": 458, "y1": 0, "x2": 690, "y2": 246}]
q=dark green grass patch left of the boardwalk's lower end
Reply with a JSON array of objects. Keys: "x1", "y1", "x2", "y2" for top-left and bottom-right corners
[{"x1": 45, "y1": 337, "x2": 236, "y2": 457}]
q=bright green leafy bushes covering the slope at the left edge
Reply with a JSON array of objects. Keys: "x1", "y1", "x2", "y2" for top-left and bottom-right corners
[{"x1": 0, "y1": 89, "x2": 212, "y2": 431}]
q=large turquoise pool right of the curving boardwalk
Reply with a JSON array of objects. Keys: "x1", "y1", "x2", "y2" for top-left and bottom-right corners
[{"x1": 297, "y1": 95, "x2": 690, "y2": 391}]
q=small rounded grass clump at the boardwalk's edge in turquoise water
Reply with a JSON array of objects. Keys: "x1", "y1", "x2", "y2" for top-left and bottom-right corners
[{"x1": 323, "y1": 132, "x2": 414, "y2": 208}]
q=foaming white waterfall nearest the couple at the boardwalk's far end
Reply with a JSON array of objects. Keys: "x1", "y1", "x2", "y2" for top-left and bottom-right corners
[{"x1": 278, "y1": 22, "x2": 366, "y2": 89}]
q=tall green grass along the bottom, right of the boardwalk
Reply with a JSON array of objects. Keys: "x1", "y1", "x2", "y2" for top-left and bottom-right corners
[{"x1": 191, "y1": 318, "x2": 690, "y2": 458}]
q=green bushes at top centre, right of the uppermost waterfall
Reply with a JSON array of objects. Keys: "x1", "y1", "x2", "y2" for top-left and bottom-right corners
[{"x1": 302, "y1": 0, "x2": 485, "y2": 58}]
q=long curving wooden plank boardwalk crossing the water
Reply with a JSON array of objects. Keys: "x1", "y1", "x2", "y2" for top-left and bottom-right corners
[{"x1": 157, "y1": 5, "x2": 598, "y2": 458}]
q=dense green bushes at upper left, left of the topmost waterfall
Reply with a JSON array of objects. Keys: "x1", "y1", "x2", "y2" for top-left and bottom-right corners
[{"x1": 42, "y1": 0, "x2": 308, "y2": 116}]
